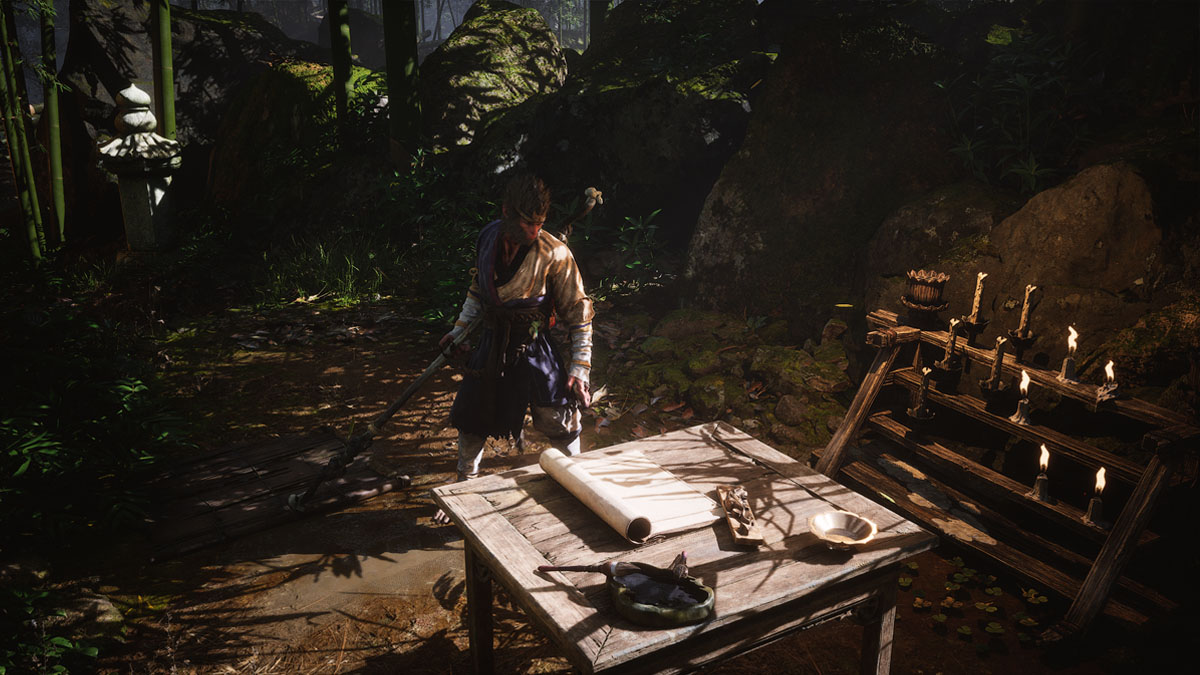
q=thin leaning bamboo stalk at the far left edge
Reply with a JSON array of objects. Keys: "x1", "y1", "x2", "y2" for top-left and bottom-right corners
[{"x1": 0, "y1": 0, "x2": 46, "y2": 262}]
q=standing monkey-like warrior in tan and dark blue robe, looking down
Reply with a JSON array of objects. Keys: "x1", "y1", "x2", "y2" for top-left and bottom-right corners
[{"x1": 434, "y1": 173, "x2": 593, "y2": 522}]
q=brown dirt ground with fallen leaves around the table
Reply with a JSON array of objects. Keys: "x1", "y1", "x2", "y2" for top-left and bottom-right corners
[{"x1": 79, "y1": 296, "x2": 1185, "y2": 675}]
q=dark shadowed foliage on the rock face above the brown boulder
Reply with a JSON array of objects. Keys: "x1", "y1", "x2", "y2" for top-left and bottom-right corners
[{"x1": 936, "y1": 26, "x2": 1103, "y2": 193}]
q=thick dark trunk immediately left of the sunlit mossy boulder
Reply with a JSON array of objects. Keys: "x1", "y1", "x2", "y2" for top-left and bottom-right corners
[{"x1": 383, "y1": 0, "x2": 421, "y2": 165}]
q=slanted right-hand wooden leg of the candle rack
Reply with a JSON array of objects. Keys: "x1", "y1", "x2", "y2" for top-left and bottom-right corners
[{"x1": 1043, "y1": 455, "x2": 1175, "y2": 639}]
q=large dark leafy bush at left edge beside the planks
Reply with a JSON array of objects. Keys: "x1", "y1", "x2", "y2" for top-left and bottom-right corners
[{"x1": 0, "y1": 283, "x2": 184, "y2": 546}]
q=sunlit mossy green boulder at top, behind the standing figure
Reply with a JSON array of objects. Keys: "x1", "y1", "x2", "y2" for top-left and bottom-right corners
[{"x1": 420, "y1": 0, "x2": 566, "y2": 151}]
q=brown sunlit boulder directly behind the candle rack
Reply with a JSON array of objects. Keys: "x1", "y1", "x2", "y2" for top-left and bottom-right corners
[{"x1": 865, "y1": 163, "x2": 1166, "y2": 365}]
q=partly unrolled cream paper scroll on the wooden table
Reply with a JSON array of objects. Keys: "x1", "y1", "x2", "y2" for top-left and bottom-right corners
[{"x1": 539, "y1": 448, "x2": 721, "y2": 544}]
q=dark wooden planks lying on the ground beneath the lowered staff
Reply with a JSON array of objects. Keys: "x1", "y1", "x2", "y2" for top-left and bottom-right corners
[{"x1": 148, "y1": 435, "x2": 403, "y2": 560}]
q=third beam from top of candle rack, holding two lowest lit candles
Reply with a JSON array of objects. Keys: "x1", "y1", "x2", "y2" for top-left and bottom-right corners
[{"x1": 868, "y1": 412, "x2": 1158, "y2": 547}]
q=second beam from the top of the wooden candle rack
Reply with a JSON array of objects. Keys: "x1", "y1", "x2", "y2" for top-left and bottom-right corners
[{"x1": 892, "y1": 369, "x2": 1141, "y2": 485}]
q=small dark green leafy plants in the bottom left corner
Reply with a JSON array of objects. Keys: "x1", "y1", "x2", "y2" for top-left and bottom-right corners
[{"x1": 0, "y1": 587, "x2": 98, "y2": 675}]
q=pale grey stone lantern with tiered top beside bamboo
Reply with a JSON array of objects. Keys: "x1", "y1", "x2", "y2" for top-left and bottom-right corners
[{"x1": 100, "y1": 84, "x2": 181, "y2": 252}]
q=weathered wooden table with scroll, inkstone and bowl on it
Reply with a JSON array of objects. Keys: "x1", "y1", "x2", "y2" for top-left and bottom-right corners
[{"x1": 433, "y1": 423, "x2": 936, "y2": 673}]
